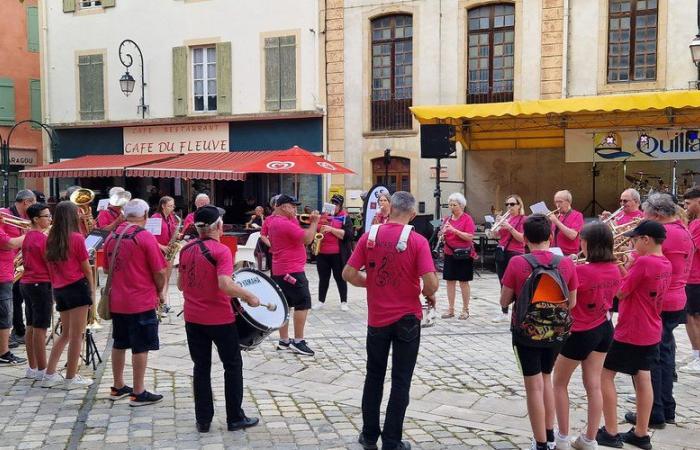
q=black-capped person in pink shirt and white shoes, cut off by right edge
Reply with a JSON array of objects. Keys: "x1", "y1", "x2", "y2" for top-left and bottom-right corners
[{"x1": 679, "y1": 186, "x2": 700, "y2": 374}]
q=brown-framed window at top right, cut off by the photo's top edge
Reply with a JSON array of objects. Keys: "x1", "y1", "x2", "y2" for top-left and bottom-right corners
[{"x1": 608, "y1": 0, "x2": 658, "y2": 83}]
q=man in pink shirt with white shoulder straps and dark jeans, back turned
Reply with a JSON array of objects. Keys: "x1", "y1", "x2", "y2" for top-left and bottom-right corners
[{"x1": 343, "y1": 191, "x2": 439, "y2": 449}]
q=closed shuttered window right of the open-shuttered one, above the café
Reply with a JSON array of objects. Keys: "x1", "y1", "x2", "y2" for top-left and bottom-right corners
[{"x1": 265, "y1": 36, "x2": 297, "y2": 111}]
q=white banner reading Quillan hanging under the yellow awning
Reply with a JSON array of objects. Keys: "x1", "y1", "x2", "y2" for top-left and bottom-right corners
[{"x1": 565, "y1": 128, "x2": 700, "y2": 162}]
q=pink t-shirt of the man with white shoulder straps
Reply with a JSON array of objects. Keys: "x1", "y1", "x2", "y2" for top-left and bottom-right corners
[{"x1": 348, "y1": 222, "x2": 435, "y2": 327}]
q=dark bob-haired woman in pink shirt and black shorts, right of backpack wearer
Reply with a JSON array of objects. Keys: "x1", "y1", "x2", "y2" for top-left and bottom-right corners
[{"x1": 552, "y1": 222, "x2": 622, "y2": 448}]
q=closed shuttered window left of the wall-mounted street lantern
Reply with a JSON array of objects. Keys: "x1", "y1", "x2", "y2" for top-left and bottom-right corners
[{"x1": 78, "y1": 54, "x2": 105, "y2": 120}]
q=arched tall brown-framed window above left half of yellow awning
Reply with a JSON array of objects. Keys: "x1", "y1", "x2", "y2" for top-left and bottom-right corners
[{"x1": 467, "y1": 5, "x2": 515, "y2": 103}]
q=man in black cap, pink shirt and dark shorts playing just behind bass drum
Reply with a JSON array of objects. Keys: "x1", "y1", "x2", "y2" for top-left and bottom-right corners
[{"x1": 263, "y1": 194, "x2": 320, "y2": 356}]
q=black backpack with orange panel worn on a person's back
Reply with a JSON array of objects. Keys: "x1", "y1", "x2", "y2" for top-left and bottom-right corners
[{"x1": 511, "y1": 254, "x2": 572, "y2": 348}]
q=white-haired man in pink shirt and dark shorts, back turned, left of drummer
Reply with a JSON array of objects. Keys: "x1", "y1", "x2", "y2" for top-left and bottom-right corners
[{"x1": 104, "y1": 199, "x2": 167, "y2": 406}]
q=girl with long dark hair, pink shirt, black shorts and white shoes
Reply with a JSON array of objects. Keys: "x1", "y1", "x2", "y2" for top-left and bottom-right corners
[{"x1": 42, "y1": 201, "x2": 95, "y2": 390}]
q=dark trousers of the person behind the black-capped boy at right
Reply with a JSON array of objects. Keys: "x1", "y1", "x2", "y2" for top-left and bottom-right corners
[{"x1": 649, "y1": 310, "x2": 685, "y2": 423}]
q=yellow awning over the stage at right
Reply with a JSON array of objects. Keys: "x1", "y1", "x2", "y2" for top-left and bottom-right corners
[{"x1": 411, "y1": 90, "x2": 700, "y2": 150}]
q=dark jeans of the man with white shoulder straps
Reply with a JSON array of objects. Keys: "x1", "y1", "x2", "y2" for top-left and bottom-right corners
[{"x1": 362, "y1": 315, "x2": 420, "y2": 449}]
